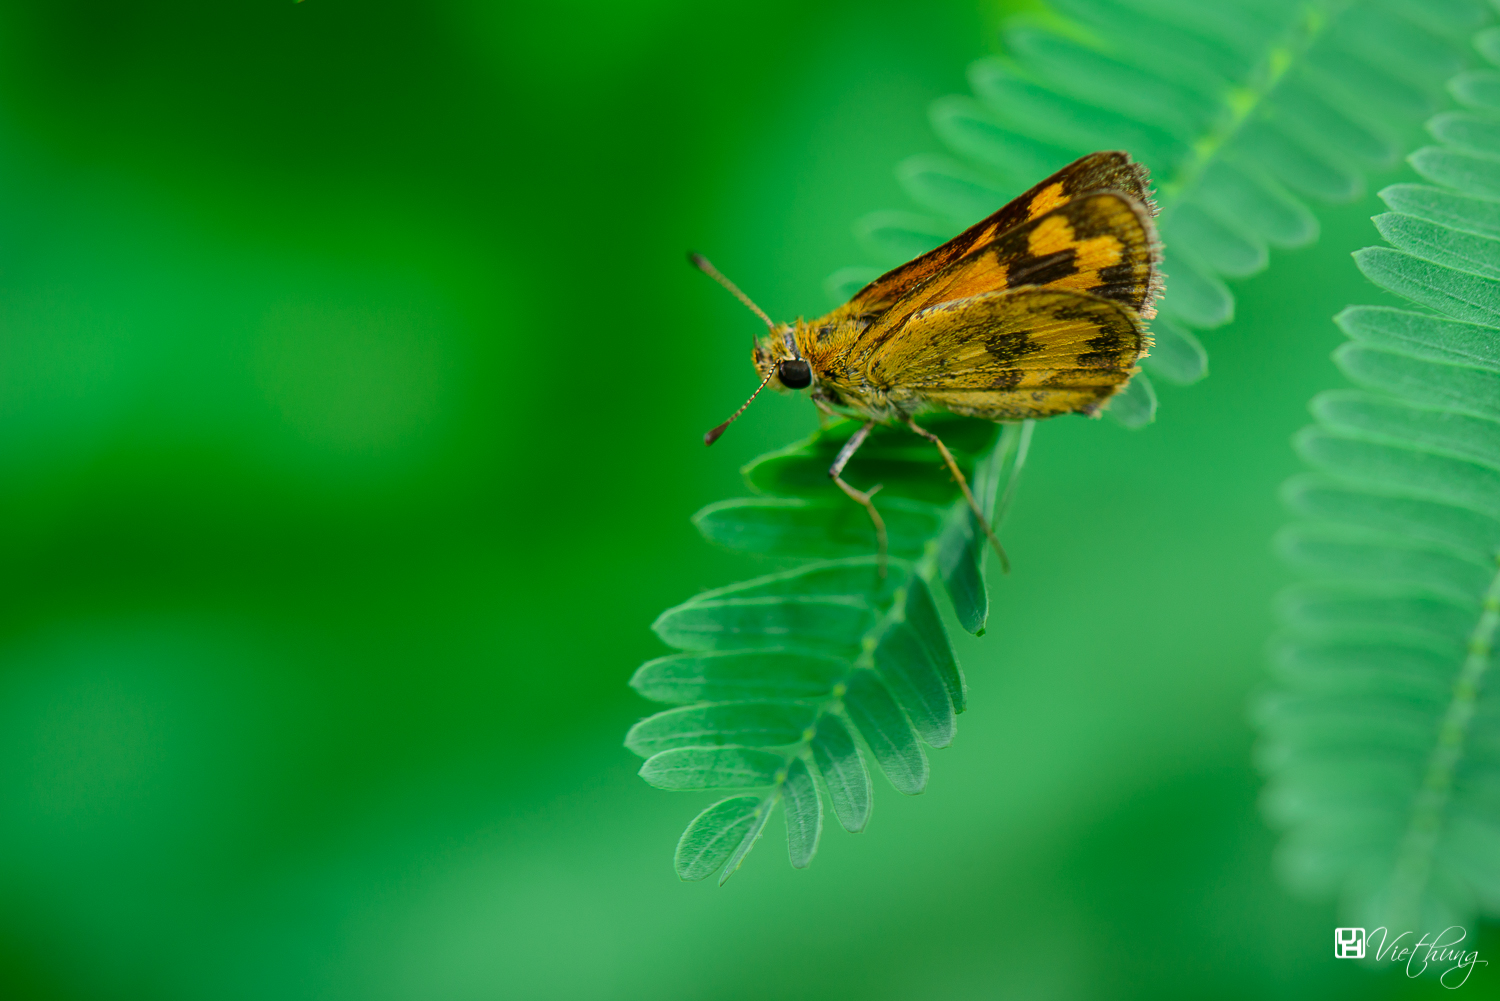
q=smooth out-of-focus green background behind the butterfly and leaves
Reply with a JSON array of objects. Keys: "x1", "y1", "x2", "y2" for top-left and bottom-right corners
[{"x1": 0, "y1": 0, "x2": 1482, "y2": 1001}]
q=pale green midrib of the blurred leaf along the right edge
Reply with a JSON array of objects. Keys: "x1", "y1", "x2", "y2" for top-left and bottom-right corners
[{"x1": 1391, "y1": 554, "x2": 1500, "y2": 927}]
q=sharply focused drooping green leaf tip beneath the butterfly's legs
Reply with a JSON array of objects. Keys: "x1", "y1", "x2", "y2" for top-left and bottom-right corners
[{"x1": 626, "y1": 414, "x2": 1031, "y2": 882}]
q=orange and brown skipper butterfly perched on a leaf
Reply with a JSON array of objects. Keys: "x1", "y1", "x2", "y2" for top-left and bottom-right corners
[{"x1": 690, "y1": 152, "x2": 1163, "y2": 566}]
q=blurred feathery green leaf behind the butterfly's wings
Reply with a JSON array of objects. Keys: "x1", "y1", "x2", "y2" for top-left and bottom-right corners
[{"x1": 828, "y1": 0, "x2": 1482, "y2": 426}]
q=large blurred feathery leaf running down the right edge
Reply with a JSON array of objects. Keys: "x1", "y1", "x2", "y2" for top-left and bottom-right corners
[{"x1": 1257, "y1": 30, "x2": 1500, "y2": 933}]
